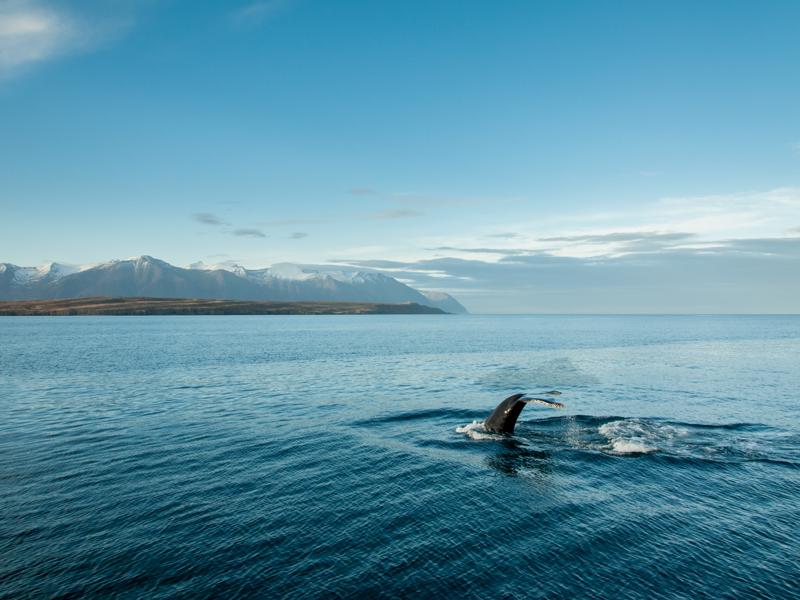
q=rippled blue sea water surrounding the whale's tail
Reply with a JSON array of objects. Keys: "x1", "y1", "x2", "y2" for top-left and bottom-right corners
[{"x1": 0, "y1": 316, "x2": 800, "y2": 600}]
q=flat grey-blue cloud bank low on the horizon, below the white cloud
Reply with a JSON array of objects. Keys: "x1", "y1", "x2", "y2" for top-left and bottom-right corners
[{"x1": 341, "y1": 238, "x2": 800, "y2": 313}]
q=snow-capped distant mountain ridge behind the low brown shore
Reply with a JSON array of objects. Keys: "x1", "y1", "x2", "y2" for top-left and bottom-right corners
[{"x1": 0, "y1": 255, "x2": 467, "y2": 313}]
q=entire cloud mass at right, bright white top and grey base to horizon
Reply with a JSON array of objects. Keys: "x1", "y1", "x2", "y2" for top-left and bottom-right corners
[{"x1": 324, "y1": 188, "x2": 800, "y2": 313}]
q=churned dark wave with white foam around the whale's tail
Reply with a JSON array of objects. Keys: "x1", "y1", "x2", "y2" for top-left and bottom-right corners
[{"x1": 352, "y1": 407, "x2": 800, "y2": 468}]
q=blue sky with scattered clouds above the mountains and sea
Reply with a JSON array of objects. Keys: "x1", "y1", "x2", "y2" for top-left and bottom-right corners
[{"x1": 0, "y1": 0, "x2": 800, "y2": 313}]
